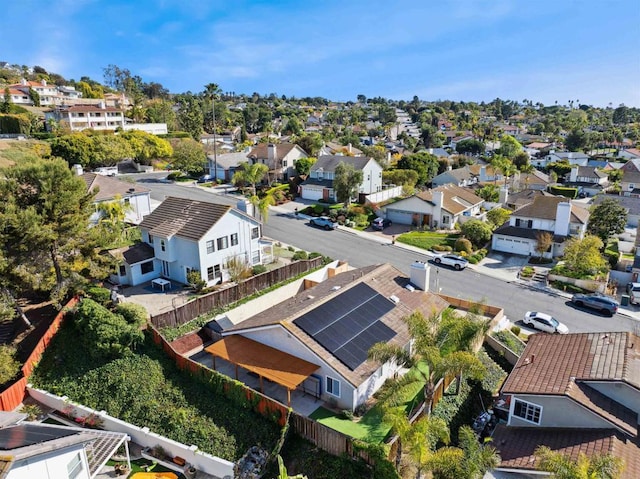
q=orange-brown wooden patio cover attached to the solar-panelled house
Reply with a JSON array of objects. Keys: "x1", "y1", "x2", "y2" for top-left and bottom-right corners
[{"x1": 205, "y1": 334, "x2": 320, "y2": 390}]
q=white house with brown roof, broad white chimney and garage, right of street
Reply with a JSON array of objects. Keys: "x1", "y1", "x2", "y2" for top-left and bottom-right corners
[{"x1": 491, "y1": 196, "x2": 589, "y2": 257}]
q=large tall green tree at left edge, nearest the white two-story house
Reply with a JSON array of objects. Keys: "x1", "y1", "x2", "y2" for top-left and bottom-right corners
[{"x1": 0, "y1": 159, "x2": 106, "y2": 301}]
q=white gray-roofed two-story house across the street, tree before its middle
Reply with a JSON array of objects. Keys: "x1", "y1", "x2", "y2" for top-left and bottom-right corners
[{"x1": 300, "y1": 155, "x2": 382, "y2": 201}]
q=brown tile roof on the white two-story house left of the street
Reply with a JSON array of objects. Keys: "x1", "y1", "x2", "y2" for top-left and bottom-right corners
[{"x1": 139, "y1": 196, "x2": 239, "y2": 241}]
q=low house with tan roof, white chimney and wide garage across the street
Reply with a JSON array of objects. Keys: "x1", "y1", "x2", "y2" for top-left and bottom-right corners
[{"x1": 382, "y1": 184, "x2": 484, "y2": 229}]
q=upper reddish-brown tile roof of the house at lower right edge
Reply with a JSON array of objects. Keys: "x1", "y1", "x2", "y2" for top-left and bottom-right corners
[{"x1": 502, "y1": 332, "x2": 640, "y2": 395}]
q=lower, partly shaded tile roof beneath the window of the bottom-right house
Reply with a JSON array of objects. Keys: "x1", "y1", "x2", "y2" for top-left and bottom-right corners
[{"x1": 492, "y1": 424, "x2": 640, "y2": 479}]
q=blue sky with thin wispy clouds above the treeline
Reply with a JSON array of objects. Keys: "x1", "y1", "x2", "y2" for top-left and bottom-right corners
[{"x1": 0, "y1": 0, "x2": 640, "y2": 107}]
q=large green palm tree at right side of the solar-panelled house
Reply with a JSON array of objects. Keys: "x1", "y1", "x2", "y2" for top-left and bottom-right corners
[{"x1": 369, "y1": 309, "x2": 487, "y2": 414}]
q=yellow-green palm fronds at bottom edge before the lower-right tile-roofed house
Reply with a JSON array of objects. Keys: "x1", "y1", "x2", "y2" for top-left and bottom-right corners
[{"x1": 535, "y1": 446, "x2": 624, "y2": 479}]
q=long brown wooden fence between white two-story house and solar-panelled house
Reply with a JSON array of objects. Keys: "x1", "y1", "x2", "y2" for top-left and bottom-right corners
[{"x1": 151, "y1": 257, "x2": 322, "y2": 328}]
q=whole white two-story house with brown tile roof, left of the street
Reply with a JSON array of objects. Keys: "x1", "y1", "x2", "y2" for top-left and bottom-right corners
[{"x1": 111, "y1": 197, "x2": 267, "y2": 286}]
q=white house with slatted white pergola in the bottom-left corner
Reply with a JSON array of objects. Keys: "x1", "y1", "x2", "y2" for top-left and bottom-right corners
[{"x1": 0, "y1": 412, "x2": 129, "y2": 479}]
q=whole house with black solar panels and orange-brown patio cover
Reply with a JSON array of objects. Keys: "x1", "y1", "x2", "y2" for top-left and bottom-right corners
[{"x1": 206, "y1": 263, "x2": 448, "y2": 410}]
